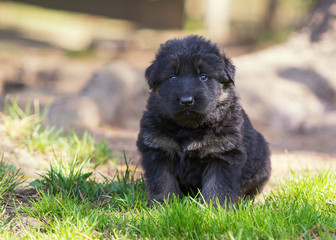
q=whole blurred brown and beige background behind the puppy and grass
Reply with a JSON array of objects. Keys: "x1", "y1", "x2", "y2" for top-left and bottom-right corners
[{"x1": 0, "y1": 0, "x2": 336, "y2": 181}]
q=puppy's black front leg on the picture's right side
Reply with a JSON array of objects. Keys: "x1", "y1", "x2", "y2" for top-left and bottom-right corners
[{"x1": 202, "y1": 150, "x2": 246, "y2": 206}]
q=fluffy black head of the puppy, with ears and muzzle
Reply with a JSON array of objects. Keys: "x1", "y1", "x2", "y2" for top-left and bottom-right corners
[{"x1": 146, "y1": 36, "x2": 234, "y2": 127}]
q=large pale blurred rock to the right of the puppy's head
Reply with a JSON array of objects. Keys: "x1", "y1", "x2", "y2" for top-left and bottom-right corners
[{"x1": 234, "y1": 36, "x2": 336, "y2": 131}]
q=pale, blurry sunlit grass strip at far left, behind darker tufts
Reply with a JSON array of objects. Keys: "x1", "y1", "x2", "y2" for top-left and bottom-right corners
[{"x1": 1, "y1": 98, "x2": 114, "y2": 164}]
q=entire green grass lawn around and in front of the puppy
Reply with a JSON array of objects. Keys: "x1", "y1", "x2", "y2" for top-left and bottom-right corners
[{"x1": 0, "y1": 98, "x2": 336, "y2": 239}]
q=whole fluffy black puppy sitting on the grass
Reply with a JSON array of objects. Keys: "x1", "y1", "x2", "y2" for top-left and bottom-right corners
[{"x1": 137, "y1": 36, "x2": 271, "y2": 205}]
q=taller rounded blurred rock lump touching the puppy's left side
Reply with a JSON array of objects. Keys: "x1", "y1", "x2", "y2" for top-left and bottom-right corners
[{"x1": 81, "y1": 61, "x2": 148, "y2": 128}]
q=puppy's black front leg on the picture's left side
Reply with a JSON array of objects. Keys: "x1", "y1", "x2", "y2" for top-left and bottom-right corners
[{"x1": 142, "y1": 150, "x2": 181, "y2": 205}]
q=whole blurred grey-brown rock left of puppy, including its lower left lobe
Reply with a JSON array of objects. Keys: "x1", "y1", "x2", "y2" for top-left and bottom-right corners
[{"x1": 48, "y1": 61, "x2": 148, "y2": 129}]
